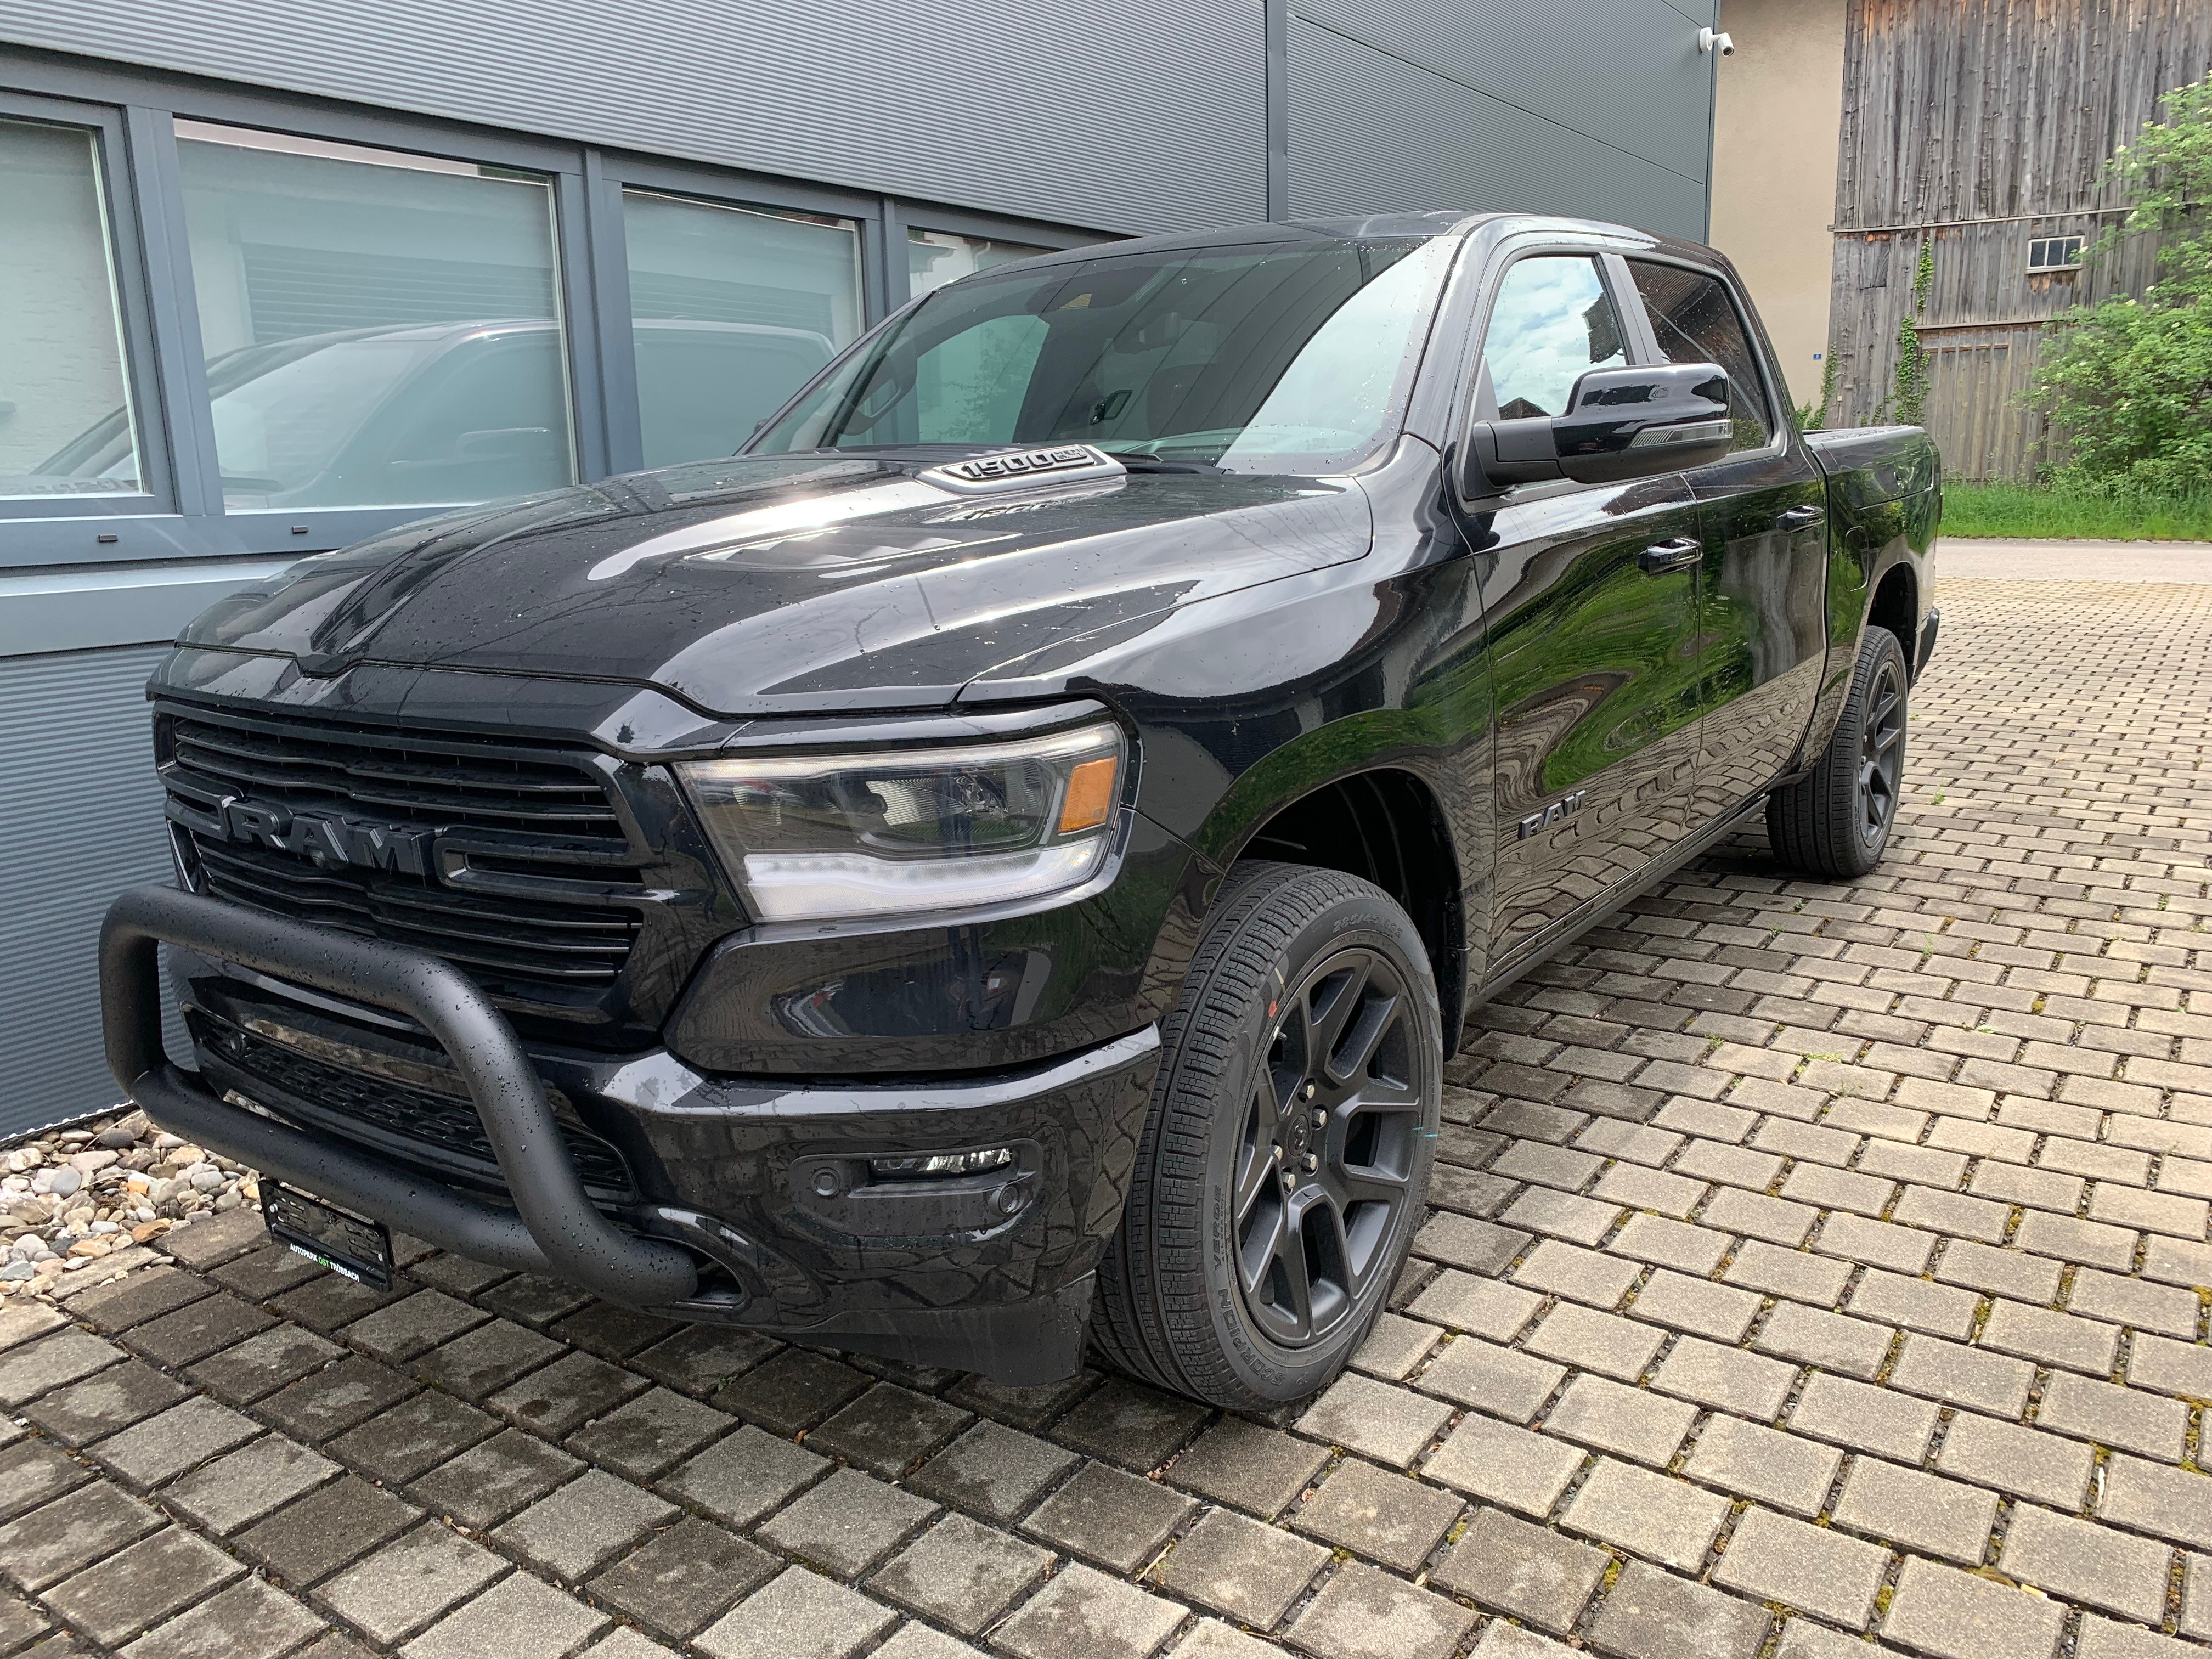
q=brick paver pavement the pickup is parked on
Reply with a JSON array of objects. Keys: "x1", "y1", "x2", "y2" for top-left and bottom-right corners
[{"x1": 0, "y1": 566, "x2": 2212, "y2": 1659}]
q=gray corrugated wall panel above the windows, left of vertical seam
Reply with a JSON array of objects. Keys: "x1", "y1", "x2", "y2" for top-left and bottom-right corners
[{"x1": 0, "y1": 0, "x2": 1267, "y2": 230}]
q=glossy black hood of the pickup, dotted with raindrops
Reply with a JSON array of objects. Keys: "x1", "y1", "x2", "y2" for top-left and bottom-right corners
[{"x1": 182, "y1": 454, "x2": 1372, "y2": 714}]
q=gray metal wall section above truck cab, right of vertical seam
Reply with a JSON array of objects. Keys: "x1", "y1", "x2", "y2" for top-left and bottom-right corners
[{"x1": 1288, "y1": 0, "x2": 1712, "y2": 239}]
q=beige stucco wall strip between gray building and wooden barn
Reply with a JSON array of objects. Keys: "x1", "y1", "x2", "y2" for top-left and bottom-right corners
[{"x1": 1712, "y1": 0, "x2": 1847, "y2": 403}]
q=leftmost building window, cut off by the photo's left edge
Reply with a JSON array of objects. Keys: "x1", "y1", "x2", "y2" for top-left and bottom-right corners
[{"x1": 0, "y1": 122, "x2": 142, "y2": 500}]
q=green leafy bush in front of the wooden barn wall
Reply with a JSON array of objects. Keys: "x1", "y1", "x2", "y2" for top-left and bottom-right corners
[{"x1": 2028, "y1": 77, "x2": 2212, "y2": 495}]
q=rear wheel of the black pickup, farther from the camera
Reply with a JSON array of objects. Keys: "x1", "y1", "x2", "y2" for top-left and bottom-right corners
[{"x1": 1768, "y1": 628, "x2": 1911, "y2": 881}]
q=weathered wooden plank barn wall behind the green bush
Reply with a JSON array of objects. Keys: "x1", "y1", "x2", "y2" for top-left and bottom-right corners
[{"x1": 1829, "y1": 0, "x2": 2212, "y2": 478}]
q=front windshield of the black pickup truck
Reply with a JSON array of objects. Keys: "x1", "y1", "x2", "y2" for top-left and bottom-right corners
[{"x1": 748, "y1": 236, "x2": 1458, "y2": 473}]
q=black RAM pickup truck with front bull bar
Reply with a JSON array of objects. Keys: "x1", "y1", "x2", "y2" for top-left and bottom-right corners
[{"x1": 101, "y1": 204, "x2": 1940, "y2": 1407}]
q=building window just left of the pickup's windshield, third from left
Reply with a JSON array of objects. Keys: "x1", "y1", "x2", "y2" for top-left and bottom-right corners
[{"x1": 622, "y1": 190, "x2": 860, "y2": 467}]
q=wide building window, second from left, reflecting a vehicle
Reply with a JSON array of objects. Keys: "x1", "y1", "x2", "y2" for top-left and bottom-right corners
[{"x1": 177, "y1": 122, "x2": 575, "y2": 511}]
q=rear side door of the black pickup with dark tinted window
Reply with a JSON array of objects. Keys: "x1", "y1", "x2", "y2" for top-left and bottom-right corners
[{"x1": 1628, "y1": 259, "x2": 1827, "y2": 823}]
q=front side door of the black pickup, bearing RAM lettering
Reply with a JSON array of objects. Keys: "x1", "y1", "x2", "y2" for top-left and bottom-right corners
[{"x1": 1473, "y1": 255, "x2": 1701, "y2": 971}]
